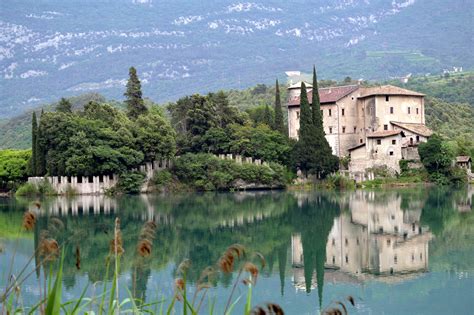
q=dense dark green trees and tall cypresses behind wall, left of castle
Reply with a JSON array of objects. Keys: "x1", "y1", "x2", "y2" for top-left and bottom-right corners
[{"x1": 30, "y1": 67, "x2": 338, "y2": 181}]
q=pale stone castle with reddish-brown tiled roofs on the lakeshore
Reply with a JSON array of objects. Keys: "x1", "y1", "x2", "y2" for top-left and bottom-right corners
[{"x1": 287, "y1": 81, "x2": 432, "y2": 173}]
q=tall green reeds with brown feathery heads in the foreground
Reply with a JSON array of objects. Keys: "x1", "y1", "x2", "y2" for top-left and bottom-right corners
[{"x1": 0, "y1": 214, "x2": 284, "y2": 315}]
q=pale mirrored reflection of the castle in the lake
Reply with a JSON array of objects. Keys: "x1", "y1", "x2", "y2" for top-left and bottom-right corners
[{"x1": 291, "y1": 191, "x2": 432, "y2": 290}]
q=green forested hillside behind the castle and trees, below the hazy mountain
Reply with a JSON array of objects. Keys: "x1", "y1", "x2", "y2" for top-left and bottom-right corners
[{"x1": 0, "y1": 72, "x2": 474, "y2": 149}]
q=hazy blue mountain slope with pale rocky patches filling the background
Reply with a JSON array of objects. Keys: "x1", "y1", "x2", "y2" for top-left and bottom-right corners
[{"x1": 0, "y1": 0, "x2": 474, "y2": 118}]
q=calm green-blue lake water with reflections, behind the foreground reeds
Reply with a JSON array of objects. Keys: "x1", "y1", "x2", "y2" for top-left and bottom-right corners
[{"x1": 0, "y1": 187, "x2": 474, "y2": 314}]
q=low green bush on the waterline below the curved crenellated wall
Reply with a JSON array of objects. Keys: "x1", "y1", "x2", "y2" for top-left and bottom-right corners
[{"x1": 172, "y1": 153, "x2": 291, "y2": 190}]
